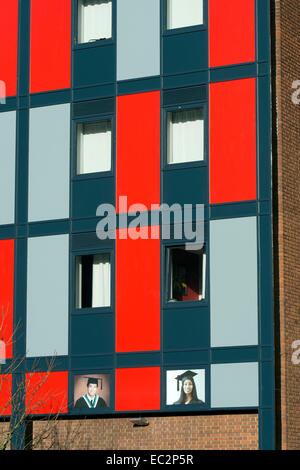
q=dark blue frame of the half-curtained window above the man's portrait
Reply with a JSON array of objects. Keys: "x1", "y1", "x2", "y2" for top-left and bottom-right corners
[{"x1": 70, "y1": 246, "x2": 115, "y2": 315}]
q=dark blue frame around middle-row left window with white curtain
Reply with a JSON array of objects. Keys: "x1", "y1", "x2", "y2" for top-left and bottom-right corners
[{"x1": 72, "y1": 114, "x2": 116, "y2": 181}]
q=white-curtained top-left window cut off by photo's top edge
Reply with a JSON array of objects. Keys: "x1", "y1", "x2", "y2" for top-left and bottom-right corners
[{"x1": 78, "y1": 0, "x2": 112, "y2": 43}]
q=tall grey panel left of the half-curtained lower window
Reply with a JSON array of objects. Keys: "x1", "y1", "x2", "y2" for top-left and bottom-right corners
[{"x1": 26, "y1": 235, "x2": 69, "y2": 357}]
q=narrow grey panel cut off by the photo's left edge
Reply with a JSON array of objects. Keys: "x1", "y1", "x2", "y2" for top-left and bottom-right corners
[{"x1": 0, "y1": 111, "x2": 16, "y2": 224}]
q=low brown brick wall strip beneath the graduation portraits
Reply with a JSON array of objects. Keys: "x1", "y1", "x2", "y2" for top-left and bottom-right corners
[{"x1": 33, "y1": 414, "x2": 258, "y2": 450}]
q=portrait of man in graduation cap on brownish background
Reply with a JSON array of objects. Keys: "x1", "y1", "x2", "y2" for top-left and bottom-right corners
[{"x1": 74, "y1": 374, "x2": 110, "y2": 409}]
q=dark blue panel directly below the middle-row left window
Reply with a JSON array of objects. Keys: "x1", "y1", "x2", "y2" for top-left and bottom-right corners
[{"x1": 72, "y1": 177, "x2": 115, "y2": 219}]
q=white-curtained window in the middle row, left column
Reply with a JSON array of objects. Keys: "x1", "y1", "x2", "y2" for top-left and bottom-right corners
[{"x1": 77, "y1": 119, "x2": 111, "y2": 175}]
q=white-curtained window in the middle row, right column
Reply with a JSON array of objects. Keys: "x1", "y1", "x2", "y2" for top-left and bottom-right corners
[{"x1": 167, "y1": 108, "x2": 204, "y2": 163}]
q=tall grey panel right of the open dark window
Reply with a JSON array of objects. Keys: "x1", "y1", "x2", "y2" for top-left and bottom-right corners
[{"x1": 210, "y1": 217, "x2": 258, "y2": 347}]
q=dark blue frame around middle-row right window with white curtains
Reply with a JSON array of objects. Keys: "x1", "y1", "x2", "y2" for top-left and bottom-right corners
[{"x1": 162, "y1": 101, "x2": 209, "y2": 171}]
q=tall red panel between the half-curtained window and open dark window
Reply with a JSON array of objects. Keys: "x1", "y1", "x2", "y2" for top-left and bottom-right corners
[{"x1": 116, "y1": 229, "x2": 160, "y2": 352}]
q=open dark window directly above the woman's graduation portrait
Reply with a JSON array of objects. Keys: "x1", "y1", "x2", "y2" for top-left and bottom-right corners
[{"x1": 167, "y1": 245, "x2": 206, "y2": 302}]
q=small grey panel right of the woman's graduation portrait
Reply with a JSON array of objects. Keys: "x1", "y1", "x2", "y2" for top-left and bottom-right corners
[{"x1": 211, "y1": 362, "x2": 259, "y2": 408}]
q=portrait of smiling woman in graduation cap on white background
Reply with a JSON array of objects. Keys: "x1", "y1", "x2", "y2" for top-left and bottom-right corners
[{"x1": 166, "y1": 369, "x2": 205, "y2": 405}]
